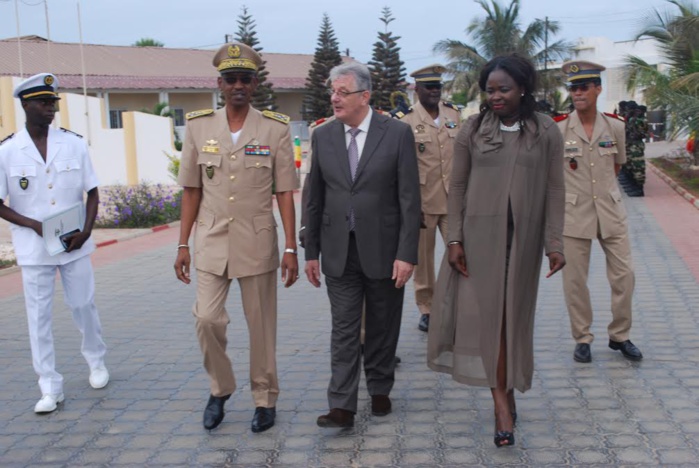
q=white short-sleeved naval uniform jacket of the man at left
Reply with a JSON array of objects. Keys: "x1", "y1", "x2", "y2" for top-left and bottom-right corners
[{"x1": 0, "y1": 127, "x2": 98, "y2": 265}]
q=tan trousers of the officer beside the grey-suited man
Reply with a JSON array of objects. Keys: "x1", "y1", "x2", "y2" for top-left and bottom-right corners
[{"x1": 194, "y1": 270, "x2": 279, "y2": 408}]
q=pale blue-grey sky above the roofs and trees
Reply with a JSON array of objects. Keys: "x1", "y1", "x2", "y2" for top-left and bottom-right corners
[{"x1": 0, "y1": 0, "x2": 671, "y2": 73}]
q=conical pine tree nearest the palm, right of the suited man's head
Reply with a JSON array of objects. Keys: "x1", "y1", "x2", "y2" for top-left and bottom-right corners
[{"x1": 369, "y1": 7, "x2": 405, "y2": 111}]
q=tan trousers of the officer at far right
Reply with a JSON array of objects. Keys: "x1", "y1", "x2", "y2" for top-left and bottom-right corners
[{"x1": 563, "y1": 234, "x2": 635, "y2": 343}]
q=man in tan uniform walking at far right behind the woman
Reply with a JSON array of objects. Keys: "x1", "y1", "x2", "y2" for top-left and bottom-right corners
[{"x1": 557, "y1": 60, "x2": 643, "y2": 362}]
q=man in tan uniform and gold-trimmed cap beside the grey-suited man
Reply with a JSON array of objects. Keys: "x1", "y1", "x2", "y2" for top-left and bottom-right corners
[{"x1": 175, "y1": 43, "x2": 298, "y2": 432}]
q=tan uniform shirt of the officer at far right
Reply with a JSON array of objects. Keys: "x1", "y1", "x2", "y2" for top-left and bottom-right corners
[{"x1": 558, "y1": 112, "x2": 627, "y2": 239}]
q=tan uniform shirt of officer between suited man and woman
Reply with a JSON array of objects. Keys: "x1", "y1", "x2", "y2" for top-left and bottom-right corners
[{"x1": 401, "y1": 101, "x2": 461, "y2": 215}]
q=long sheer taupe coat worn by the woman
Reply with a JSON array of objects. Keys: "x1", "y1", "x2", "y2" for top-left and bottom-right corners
[{"x1": 427, "y1": 113, "x2": 565, "y2": 392}]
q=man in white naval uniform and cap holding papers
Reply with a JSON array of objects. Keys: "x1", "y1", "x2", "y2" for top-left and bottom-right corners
[{"x1": 0, "y1": 73, "x2": 109, "y2": 413}]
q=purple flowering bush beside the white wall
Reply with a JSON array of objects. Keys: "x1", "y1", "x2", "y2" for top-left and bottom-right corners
[{"x1": 96, "y1": 182, "x2": 182, "y2": 228}]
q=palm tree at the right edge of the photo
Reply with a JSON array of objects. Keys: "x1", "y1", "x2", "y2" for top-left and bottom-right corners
[{"x1": 626, "y1": 0, "x2": 699, "y2": 165}]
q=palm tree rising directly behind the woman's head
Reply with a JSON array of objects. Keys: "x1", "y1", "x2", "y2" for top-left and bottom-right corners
[{"x1": 433, "y1": 0, "x2": 572, "y2": 100}]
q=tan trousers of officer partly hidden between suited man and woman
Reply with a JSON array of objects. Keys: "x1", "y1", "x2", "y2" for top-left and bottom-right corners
[{"x1": 413, "y1": 214, "x2": 447, "y2": 314}]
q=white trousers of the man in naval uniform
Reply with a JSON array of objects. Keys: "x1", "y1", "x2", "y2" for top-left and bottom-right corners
[{"x1": 22, "y1": 255, "x2": 107, "y2": 394}]
